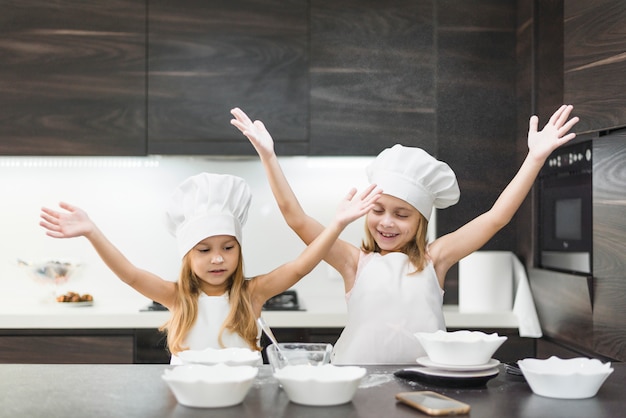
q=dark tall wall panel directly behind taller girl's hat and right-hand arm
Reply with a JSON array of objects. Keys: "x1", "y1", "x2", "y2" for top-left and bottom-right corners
[{"x1": 436, "y1": 0, "x2": 517, "y2": 303}]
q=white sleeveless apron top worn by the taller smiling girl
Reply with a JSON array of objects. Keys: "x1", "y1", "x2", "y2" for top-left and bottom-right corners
[{"x1": 332, "y1": 252, "x2": 445, "y2": 364}]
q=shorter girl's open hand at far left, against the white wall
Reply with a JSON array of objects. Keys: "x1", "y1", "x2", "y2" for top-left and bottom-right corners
[{"x1": 39, "y1": 202, "x2": 94, "y2": 238}]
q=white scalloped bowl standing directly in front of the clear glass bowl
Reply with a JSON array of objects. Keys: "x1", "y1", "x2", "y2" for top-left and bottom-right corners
[{"x1": 274, "y1": 364, "x2": 366, "y2": 406}]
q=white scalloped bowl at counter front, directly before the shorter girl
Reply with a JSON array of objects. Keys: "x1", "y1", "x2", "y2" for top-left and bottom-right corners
[{"x1": 161, "y1": 364, "x2": 259, "y2": 408}]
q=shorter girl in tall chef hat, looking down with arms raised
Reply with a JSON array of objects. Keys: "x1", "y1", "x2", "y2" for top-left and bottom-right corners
[{"x1": 40, "y1": 173, "x2": 380, "y2": 363}]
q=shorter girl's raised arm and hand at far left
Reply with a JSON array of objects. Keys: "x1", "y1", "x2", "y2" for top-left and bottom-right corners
[{"x1": 39, "y1": 202, "x2": 175, "y2": 307}]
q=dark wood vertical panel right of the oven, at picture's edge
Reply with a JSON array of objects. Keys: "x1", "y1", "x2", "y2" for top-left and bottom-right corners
[{"x1": 593, "y1": 130, "x2": 626, "y2": 360}]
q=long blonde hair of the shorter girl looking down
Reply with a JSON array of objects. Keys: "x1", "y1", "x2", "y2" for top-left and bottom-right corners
[{"x1": 160, "y1": 246, "x2": 259, "y2": 354}]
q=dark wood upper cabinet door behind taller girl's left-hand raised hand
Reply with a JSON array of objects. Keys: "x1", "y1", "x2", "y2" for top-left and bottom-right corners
[{"x1": 148, "y1": 0, "x2": 309, "y2": 155}]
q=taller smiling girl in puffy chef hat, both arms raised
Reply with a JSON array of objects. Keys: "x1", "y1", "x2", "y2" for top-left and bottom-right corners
[{"x1": 231, "y1": 106, "x2": 578, "y2": 364}]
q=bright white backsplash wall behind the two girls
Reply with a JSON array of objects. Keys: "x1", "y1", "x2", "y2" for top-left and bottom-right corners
[{"x1": 0, "y1": 156, "x2": 390, "y2": 303}]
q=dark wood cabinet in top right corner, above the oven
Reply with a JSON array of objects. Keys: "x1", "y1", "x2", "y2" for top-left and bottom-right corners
[{"x1": 564, "y1": 0, "x2": 626, "y2": 132}]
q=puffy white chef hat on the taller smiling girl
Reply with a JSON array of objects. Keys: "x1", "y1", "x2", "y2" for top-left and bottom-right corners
[{"x1": 366, "y1": 144, "x2": 460, "y2": 220}]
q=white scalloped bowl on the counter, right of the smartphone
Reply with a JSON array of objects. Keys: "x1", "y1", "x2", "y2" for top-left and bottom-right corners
[{"x1": 517, "y1": 356, "x2": 613, "y2": 399}]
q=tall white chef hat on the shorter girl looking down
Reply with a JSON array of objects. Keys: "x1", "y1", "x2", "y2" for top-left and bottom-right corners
[{"x1": 166, "y1": 173, "x2": 252, "y2": 258}]
